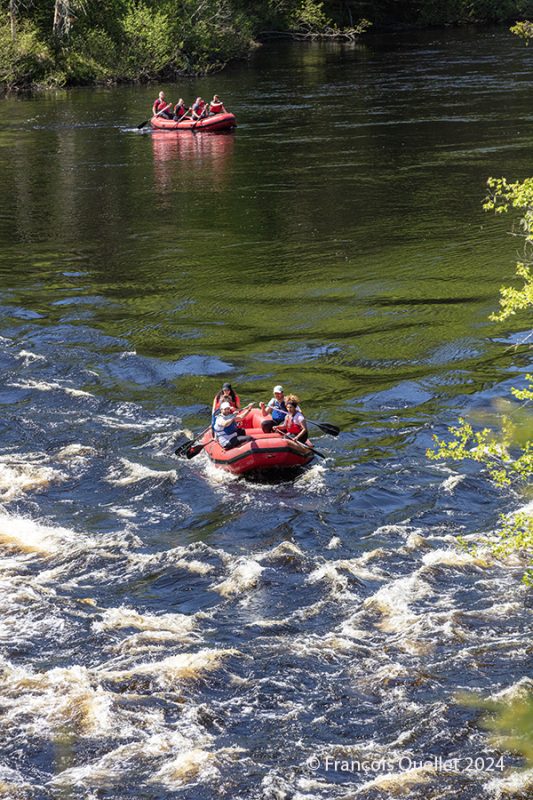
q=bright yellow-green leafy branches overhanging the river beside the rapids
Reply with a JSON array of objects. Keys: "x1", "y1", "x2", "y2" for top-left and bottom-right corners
[{"x1": 427, "y1": 178, "x2": 533, "y2": 586}]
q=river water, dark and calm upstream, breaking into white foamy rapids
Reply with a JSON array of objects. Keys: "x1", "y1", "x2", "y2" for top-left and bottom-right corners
[{"x1": 0, "y1": 29, "x2": 533, "y2": 800}]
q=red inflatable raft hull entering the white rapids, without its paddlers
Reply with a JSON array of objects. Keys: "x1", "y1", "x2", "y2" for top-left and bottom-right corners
[{"x1": 200, "y1": 410, "x2": 314, "y2": 475}]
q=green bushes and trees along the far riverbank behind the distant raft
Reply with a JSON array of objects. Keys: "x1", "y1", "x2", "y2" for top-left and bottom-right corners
[{"x1": 0, "y1": 0, "x2": 533, "y2": 91}]
